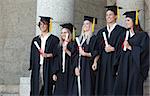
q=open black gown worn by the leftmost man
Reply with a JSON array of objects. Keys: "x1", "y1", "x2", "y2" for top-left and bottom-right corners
[{"x1": 29, "y1": 34, "x2": 59, "y2": 96}]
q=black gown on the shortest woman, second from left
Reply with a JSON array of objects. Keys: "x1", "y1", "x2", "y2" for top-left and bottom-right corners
[{"x1": 54, "y1": 42, "x2": 72, "y2": 96}]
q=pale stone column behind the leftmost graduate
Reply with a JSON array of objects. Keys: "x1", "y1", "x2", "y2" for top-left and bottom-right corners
[{"x1": 36, "y1": 0, "x2": 74, "y2": 36}]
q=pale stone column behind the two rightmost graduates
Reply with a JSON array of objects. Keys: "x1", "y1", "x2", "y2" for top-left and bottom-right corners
[{"x1": 116, "y1": 0, "x2": 145, "y2": 29}]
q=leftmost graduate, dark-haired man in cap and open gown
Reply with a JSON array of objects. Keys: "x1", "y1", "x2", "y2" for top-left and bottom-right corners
[{"x1": 29, "y1": 16, "x2": 59, "y2": 96}]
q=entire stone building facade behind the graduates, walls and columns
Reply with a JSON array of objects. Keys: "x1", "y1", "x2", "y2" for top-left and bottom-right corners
[{"x1": 0, "y1": 0, "x2": 150, "y2": 96}]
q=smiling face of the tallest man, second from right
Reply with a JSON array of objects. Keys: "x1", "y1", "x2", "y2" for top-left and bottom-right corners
[{"x1": 106, "y1": 10, "x2": 117, "y2": 23}]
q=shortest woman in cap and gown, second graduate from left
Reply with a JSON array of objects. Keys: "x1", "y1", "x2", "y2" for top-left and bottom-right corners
[{"x1": 54, "y1": 23, "x2": 75, "y2": 96}]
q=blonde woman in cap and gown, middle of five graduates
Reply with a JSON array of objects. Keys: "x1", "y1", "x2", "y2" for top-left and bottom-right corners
[{"x1": 70, "y1": 16, "x2": 97, "y2": 96}]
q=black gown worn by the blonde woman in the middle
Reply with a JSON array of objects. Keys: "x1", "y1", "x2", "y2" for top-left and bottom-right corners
[{"x1": 69, "y1": 35, "x2": 97, "y2": 96}]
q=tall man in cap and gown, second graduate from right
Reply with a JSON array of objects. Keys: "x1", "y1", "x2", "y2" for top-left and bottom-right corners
[{"x1": 95, "y1": 5, "x2": 126, "y2": 96}]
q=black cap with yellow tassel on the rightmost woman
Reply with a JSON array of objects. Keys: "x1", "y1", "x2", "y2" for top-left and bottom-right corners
[{"x1": 123, "y1": 9, "x2": 140, "y2": 25}]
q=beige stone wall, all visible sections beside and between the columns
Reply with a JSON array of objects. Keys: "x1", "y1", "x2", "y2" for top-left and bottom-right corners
[{"x1": 0, "y1": 0, "x2": 150, "y2": 96}]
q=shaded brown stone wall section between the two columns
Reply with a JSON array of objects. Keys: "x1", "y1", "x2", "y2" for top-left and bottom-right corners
[{"x1": 74, "y1": 0, "x2": 107, "y2": 34}]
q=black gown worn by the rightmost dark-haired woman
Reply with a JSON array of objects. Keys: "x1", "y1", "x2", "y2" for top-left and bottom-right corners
[{"x1": 114, "y1": 32, "x2": 149, "y2": 96}]
